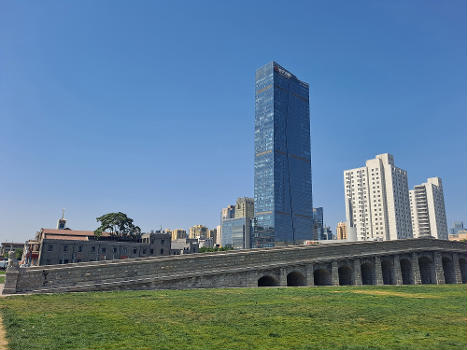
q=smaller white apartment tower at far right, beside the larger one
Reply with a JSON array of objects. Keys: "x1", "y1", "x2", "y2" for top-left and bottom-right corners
[{"x1": 409, "y1": 177, "x2": 448, "y2": 239}]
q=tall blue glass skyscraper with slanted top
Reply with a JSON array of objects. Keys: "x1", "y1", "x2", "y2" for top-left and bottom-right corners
[{"x1": 251, "y1": 62, "x2": 313, "y2": 248}]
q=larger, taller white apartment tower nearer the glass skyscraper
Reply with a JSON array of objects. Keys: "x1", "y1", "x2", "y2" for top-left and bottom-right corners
[{"x1": 344, "y1": 153, "x2": 412, "y2": 241}]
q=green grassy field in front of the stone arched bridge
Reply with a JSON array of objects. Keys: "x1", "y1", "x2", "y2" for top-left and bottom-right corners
[{"x1": 0, "y1": 285, "x2": 467, "y2": 350}]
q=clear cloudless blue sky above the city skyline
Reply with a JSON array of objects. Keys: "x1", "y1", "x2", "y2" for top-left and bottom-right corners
[{"x1": 0, "y1": 0, "x2": 467, "y2": 241}]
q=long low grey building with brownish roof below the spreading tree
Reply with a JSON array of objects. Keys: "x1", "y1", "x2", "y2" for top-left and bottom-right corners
[{"x1": 22, "y1": 228, "x2": 171, "y2": 265}]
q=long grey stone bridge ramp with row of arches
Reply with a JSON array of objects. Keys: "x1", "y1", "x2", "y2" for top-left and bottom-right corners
[{"x1": 3, "y1": 238, "x2": 467, "y2": 294}]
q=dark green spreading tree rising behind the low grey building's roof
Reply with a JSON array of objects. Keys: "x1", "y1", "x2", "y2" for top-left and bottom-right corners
[{"x1": 94, "y1": 212, "x2": 141, "y2": 238}]
